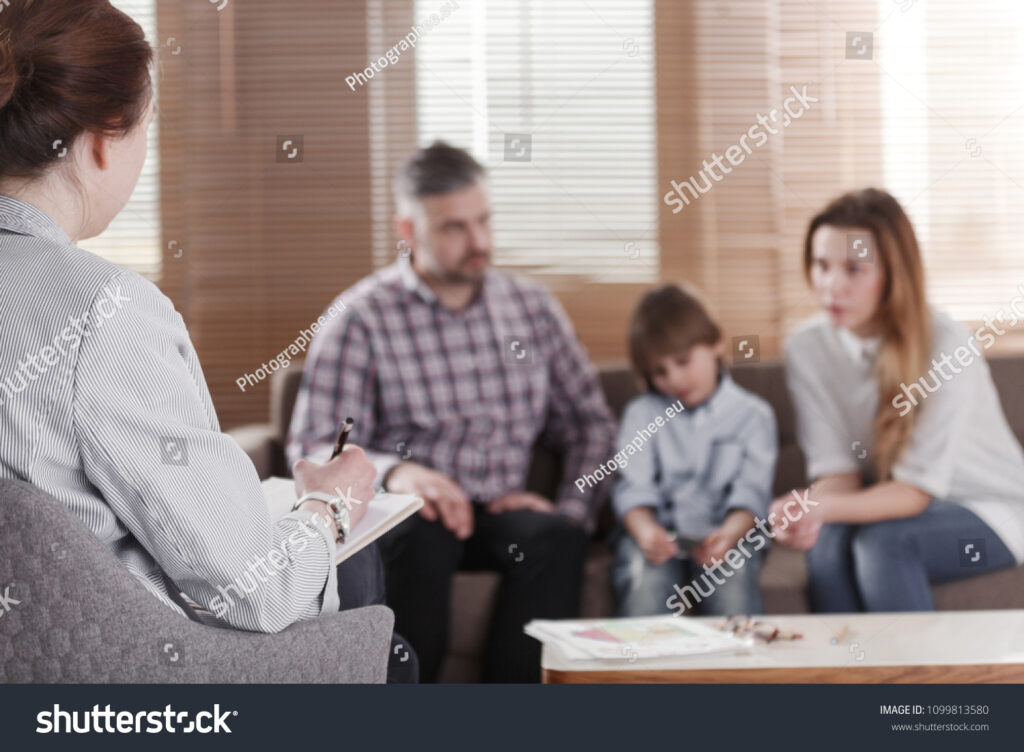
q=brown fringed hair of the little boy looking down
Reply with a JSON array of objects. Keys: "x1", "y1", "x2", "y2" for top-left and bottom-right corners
[{"x1": 630, "y1": 283, "x2": 722, "y2": 390}]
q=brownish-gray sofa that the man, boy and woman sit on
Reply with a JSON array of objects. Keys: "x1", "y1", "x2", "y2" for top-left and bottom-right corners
[{"x1": 229, "y1": 357, "x2": 1024, "y2": 681}]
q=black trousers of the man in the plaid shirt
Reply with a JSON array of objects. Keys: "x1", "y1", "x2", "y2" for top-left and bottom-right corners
[{"x1": 379, "y1": 504, "x2": 587, "y2": 682}]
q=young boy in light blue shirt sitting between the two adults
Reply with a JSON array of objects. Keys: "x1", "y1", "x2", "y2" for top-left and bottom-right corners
[{"x1": 611, "y1": 285, "x2": 778, "y2": 616}]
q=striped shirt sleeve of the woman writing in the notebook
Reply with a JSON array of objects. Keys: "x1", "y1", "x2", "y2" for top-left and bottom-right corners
[{"x1": 72, "y1": 273, "x2": 339, "y2": 632}]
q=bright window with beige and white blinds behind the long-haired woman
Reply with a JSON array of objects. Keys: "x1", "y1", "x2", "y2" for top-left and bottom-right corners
[{"x1": 657, "y1": 0, "x2": 1024, "y2": 357}]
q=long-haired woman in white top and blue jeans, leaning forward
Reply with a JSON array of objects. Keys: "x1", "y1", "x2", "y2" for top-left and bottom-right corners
[{"x1": 772, "y1": 189, "x2": 1024, "y2": 612}]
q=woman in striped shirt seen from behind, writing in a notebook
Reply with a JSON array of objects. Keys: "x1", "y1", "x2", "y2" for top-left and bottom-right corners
[{"x1": 0, "y1": 0, "x2": 407, "y2": 676}]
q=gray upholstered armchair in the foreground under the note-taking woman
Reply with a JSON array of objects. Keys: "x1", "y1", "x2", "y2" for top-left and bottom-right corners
[{"x1": 0, "y1": 479, "x2": 394, "y2": 683}]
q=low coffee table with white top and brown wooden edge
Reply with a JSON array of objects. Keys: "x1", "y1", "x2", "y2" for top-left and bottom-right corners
[{"x1": 541, "y1": 610, "x2": 1024, "y2": 684}]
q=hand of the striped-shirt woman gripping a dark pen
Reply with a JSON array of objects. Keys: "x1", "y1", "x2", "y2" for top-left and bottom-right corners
[{"x1": 292, "y1": 444, "x2": 377, "y2": 538}]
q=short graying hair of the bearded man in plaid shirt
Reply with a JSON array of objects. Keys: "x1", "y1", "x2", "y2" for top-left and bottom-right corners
[{"x1": 393, "y1": 140, "x2": 486, "y2": 214}]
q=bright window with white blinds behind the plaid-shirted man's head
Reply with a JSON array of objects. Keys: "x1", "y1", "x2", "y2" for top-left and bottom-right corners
[{"x1": 371, "y1": 0, "x2": 658, "y2": 283}]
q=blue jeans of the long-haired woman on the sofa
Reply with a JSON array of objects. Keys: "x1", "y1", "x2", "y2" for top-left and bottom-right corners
[{"x1": 807, "y1": 499, "x2": 1016, "y2": 613}]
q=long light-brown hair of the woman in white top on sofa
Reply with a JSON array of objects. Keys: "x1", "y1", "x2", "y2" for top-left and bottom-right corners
[{"x1": 804, "y1": 189, "x2": 932, "y2": 482}]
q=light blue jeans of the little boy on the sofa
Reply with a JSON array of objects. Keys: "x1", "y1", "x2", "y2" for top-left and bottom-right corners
[{"x1": 609, "y1": 529, "x2": 765, "y2": 617}]
